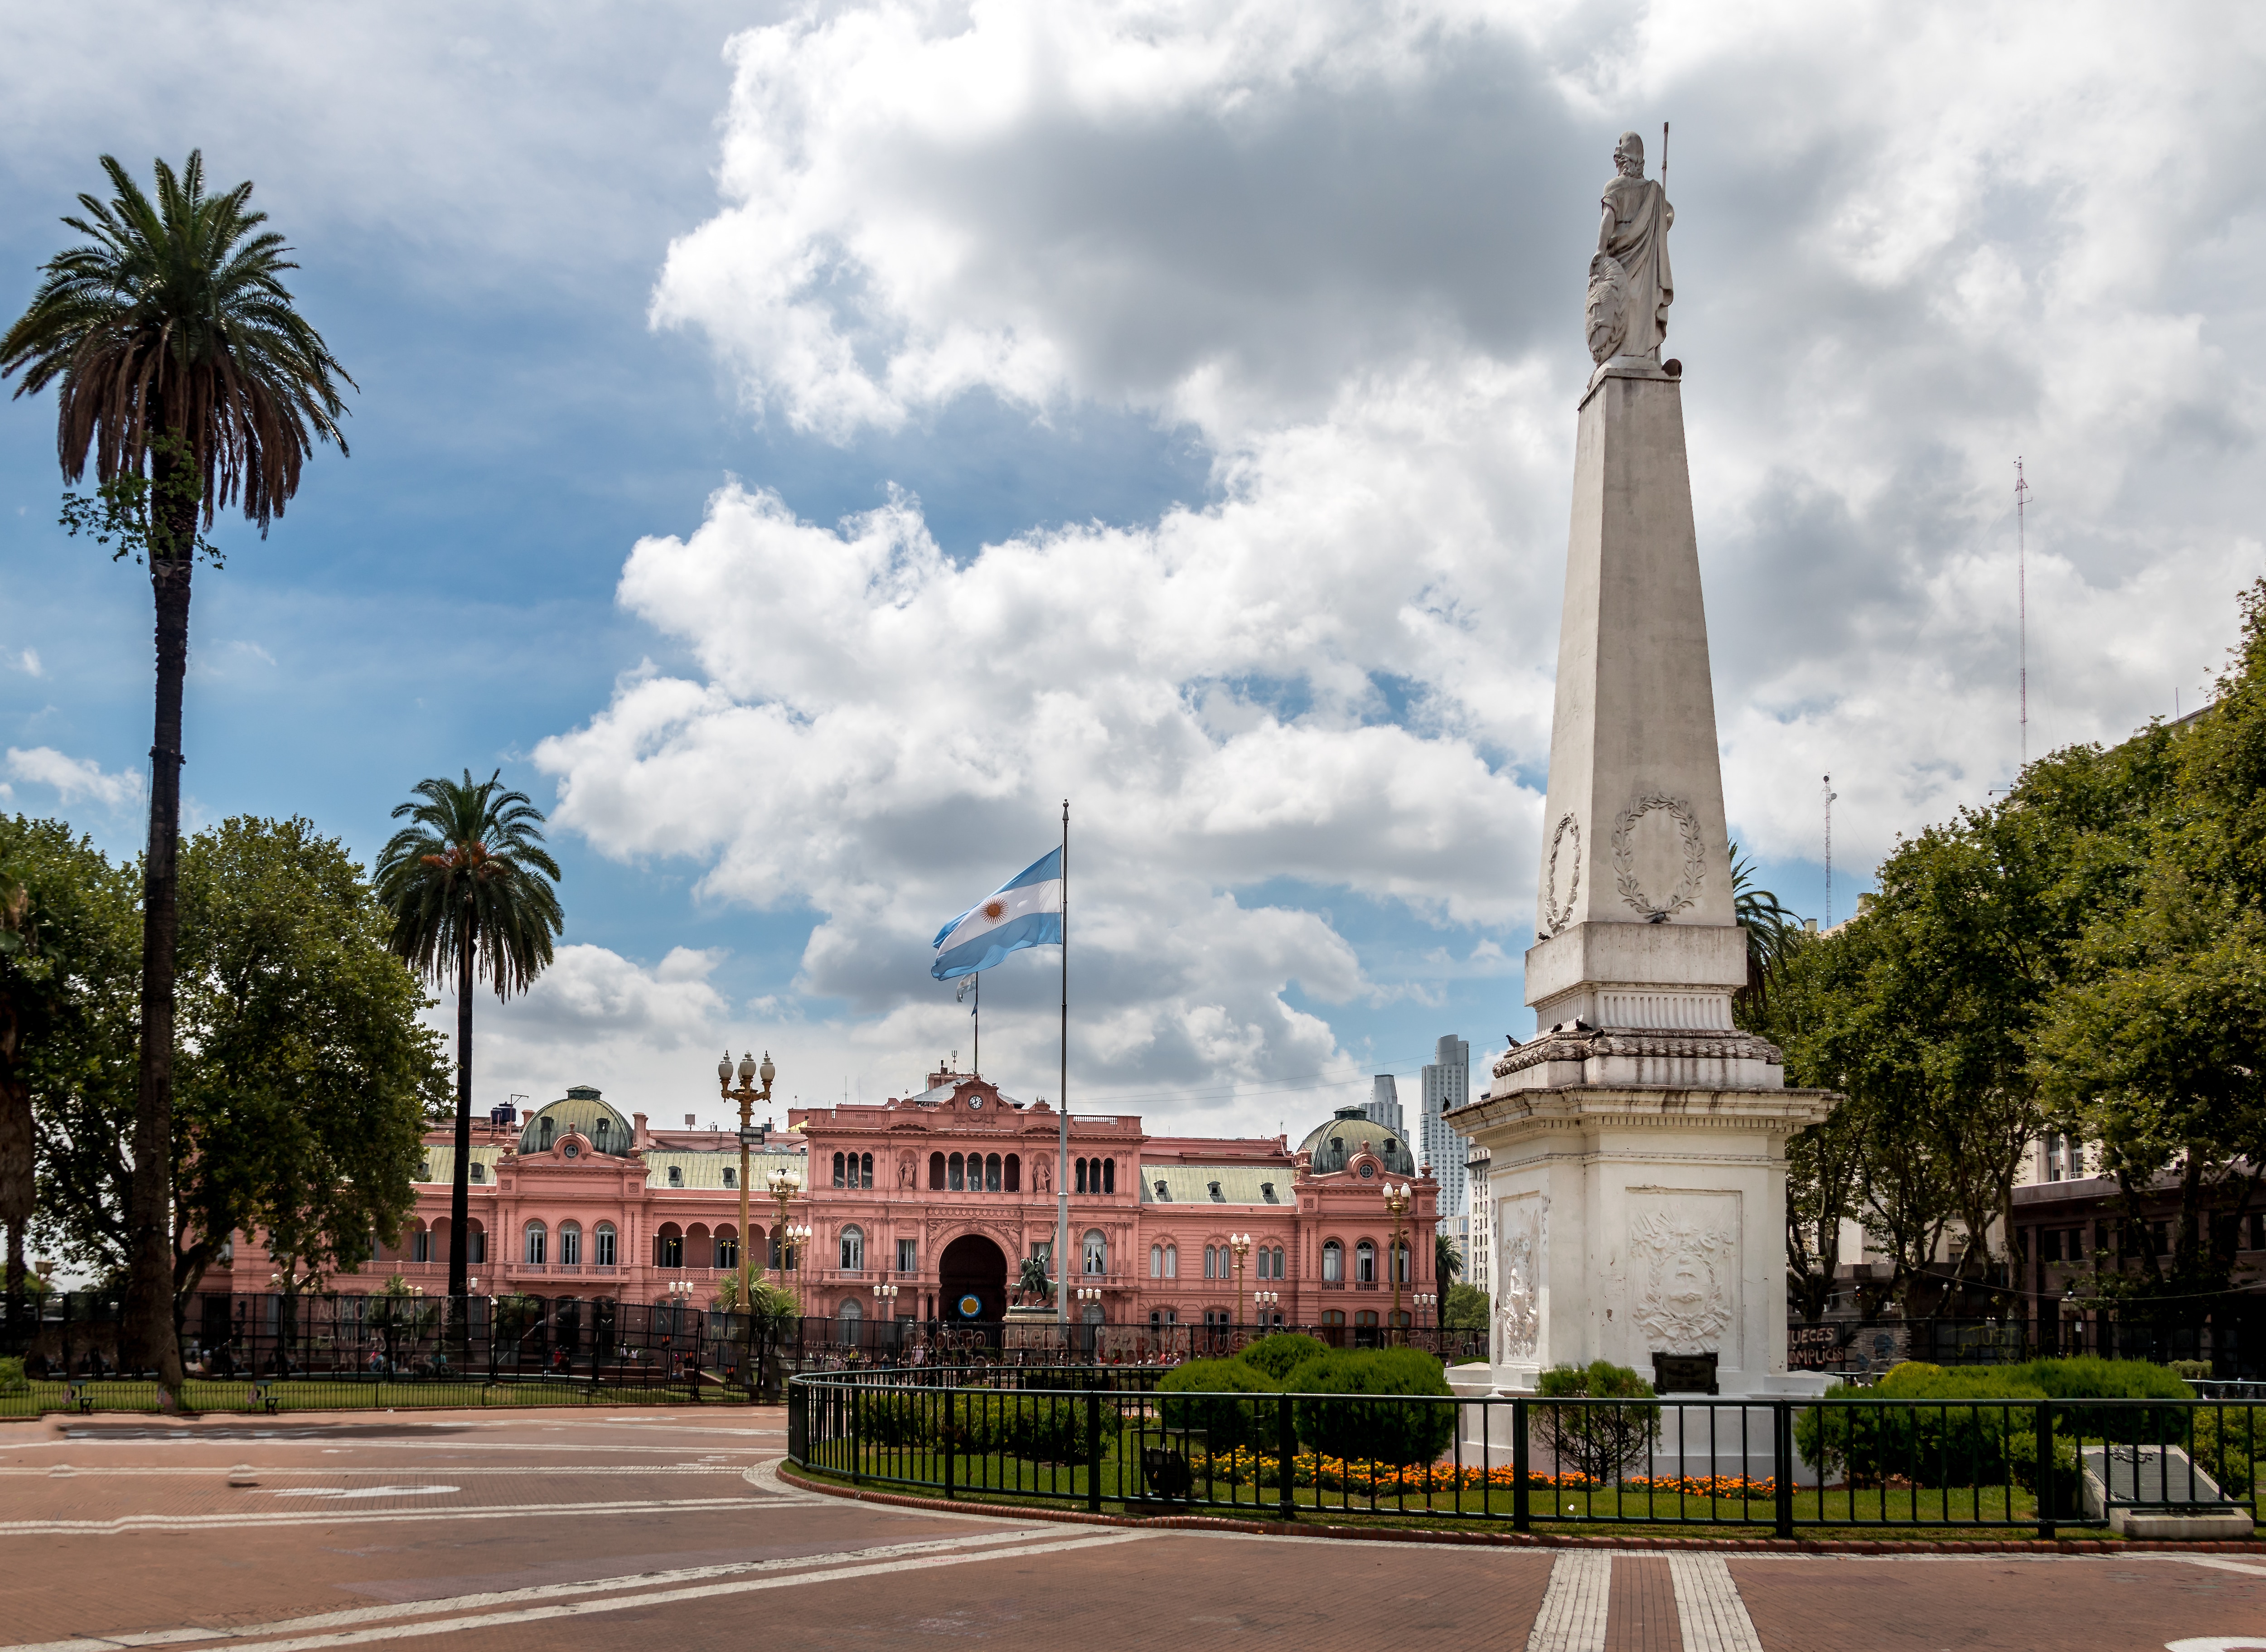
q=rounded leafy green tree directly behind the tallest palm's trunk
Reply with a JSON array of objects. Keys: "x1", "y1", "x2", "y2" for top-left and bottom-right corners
[{"x1": 39, "y1": 818, "x2": 446, "y2": 1314}]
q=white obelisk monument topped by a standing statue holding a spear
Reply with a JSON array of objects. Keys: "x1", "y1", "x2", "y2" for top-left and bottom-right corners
[{"x1": 1455, "y1": 134, "x2": 1838, "y2": 1396}]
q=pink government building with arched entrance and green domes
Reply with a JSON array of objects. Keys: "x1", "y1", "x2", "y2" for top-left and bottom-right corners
[{"x1": 265, "y1": 1070, "x2": 1441, "y2": 1326}]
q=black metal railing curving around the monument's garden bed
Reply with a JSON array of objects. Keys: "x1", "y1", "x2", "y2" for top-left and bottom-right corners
[{"x1": 786, "y1": 1367, "x2": 2266, "y2": 1536}]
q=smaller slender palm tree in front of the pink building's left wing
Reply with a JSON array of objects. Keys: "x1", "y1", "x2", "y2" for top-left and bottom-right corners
[{"x1": 378, "y1": 768, "x2": 564, "y2": 1296}]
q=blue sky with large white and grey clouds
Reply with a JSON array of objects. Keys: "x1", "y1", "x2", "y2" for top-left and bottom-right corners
[{"x1": 0, "y1": 0, "x2": 2266, "y2": 1131}]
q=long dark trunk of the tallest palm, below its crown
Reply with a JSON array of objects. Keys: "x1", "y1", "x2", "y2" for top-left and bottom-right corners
[{"x1": 120, "y1": 548, "x2": 195, "y2": 1389}]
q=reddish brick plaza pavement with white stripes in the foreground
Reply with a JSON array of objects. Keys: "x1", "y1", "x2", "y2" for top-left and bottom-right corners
[{"x1": 0, "y1": 1410, "x2": 2266, "y2": 1652}]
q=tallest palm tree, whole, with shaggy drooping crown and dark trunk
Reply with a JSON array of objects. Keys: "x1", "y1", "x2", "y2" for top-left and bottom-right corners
[{"x1": 0, "y1": 150, "x2": 353, "y2": 1385}]
